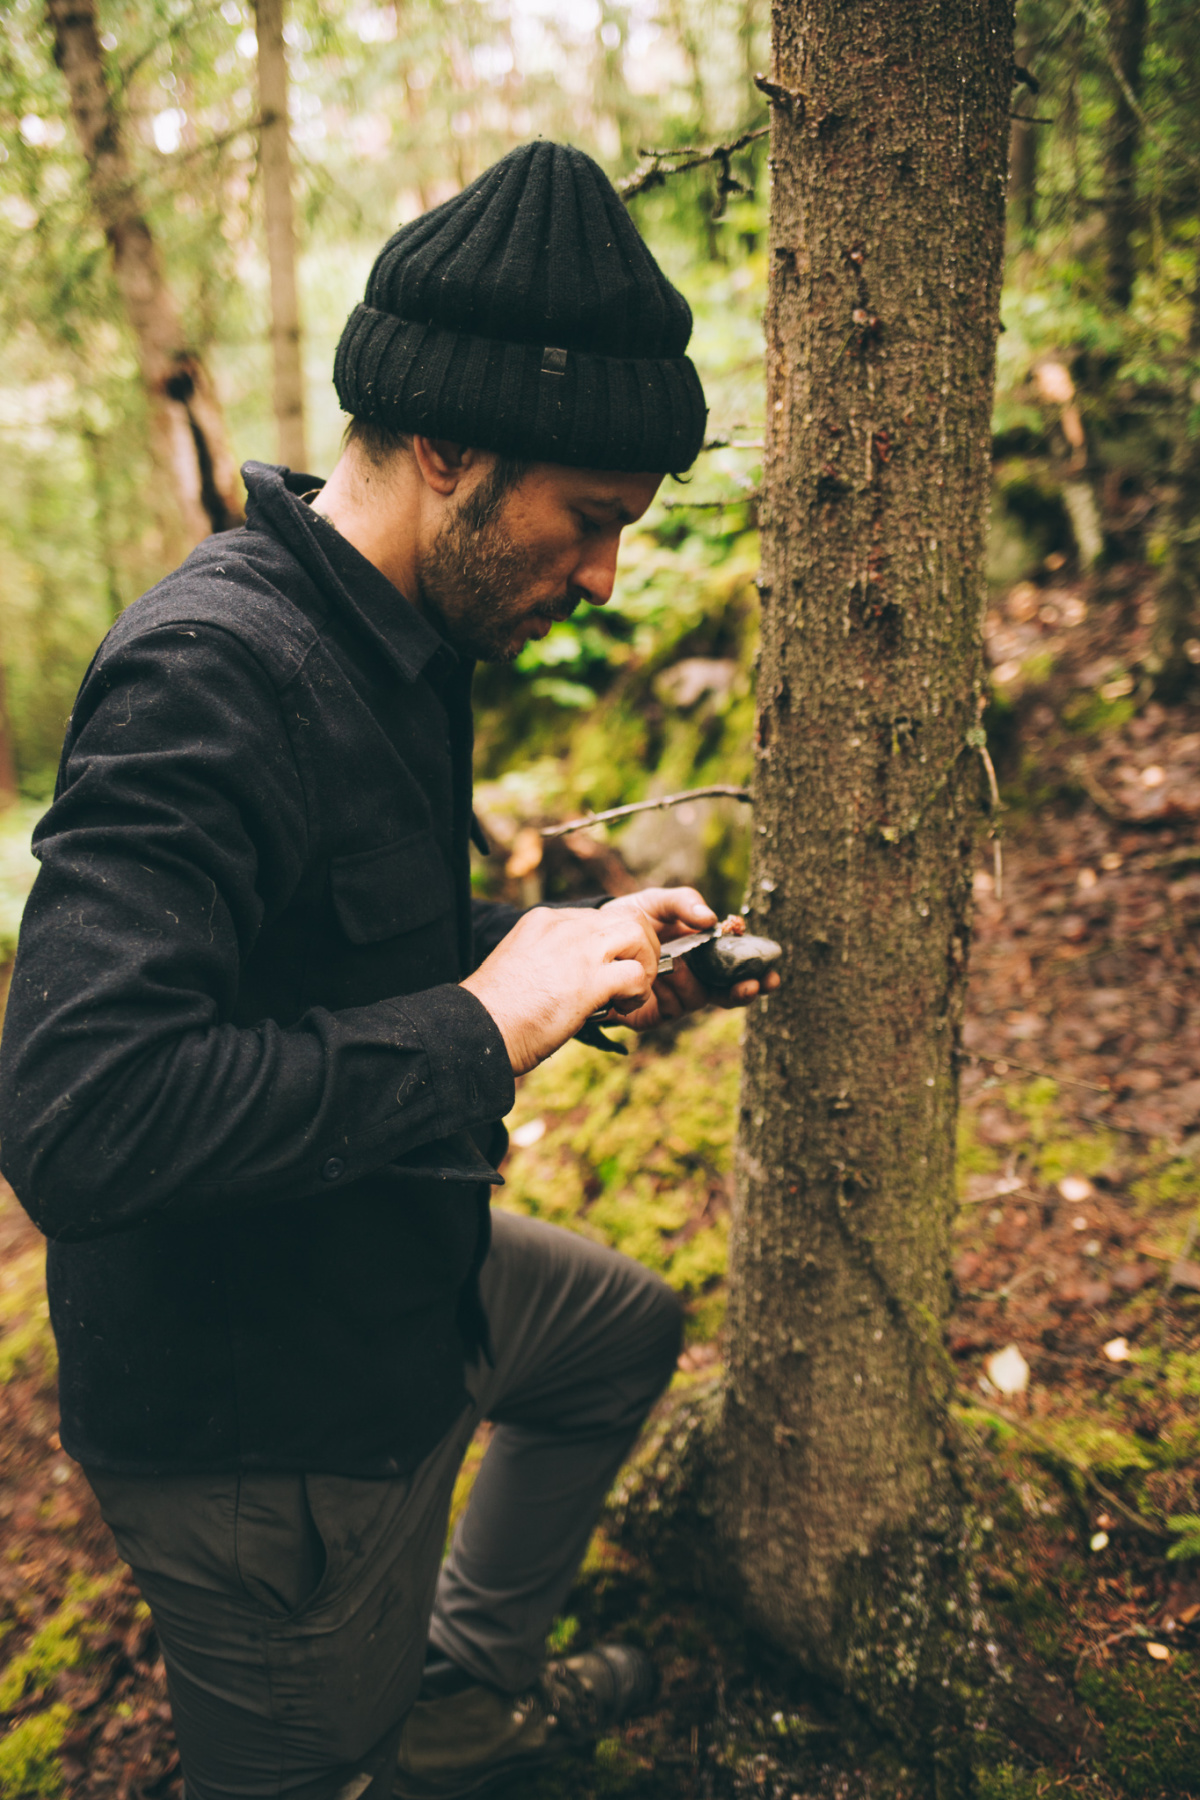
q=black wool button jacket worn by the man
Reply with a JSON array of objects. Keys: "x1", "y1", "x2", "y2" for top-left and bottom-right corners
[{"x1": 0, "y1": 463, "x2": 543, "y2": 1476}]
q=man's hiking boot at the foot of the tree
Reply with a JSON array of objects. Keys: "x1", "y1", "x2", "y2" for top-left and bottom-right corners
[{"x1": 396, "y1": 1643, "x2": 657, "y2": 1800}]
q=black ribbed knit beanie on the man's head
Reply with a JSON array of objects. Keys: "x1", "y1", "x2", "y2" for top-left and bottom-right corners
[{"x1": 333, "y1": 142, "x2": 705, "y2": 472}]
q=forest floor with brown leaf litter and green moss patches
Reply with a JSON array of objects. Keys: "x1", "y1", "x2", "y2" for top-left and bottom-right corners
[{"x1": 0, "y1": 569, "x2": 1200, "y2": 1800}]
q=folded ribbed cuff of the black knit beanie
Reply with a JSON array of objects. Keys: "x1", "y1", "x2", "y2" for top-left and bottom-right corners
[{"x1": 333, "y1": 306, "x2": 707, "y2": 473}]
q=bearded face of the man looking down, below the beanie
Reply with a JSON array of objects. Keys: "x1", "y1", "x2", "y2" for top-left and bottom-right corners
[{"x1": 417, "y1": 463, "x2": 662, "y2": 662}]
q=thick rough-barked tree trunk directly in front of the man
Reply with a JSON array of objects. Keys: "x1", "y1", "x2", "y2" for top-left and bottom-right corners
[{"x1": 718, "y1": 0, "x2": 1013, "y2": 1791}]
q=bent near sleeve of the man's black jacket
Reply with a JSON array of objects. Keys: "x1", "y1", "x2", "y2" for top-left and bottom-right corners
[{"x1": 0, "y1": 625, "x2": 513, "y2": 1238}]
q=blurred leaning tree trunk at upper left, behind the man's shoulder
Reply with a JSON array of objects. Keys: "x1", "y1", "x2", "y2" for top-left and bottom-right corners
[{"x1": 47, "y1": 0, "x2": 243, "y2": 560}]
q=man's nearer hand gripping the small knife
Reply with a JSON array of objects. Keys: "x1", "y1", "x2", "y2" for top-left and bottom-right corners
[{"x1": 462, "y1": 895, "x2": 665, "y2": 1075}]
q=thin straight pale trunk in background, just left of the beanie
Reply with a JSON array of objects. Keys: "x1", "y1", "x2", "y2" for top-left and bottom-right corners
[{"x1": 254, "y1": 0, "x2": 308, "y2": 470}]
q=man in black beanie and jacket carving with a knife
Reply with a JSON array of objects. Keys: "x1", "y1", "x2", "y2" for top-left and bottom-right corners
[{"x1": 0, "y1": 144, "x2": 780, "y2": 1800}]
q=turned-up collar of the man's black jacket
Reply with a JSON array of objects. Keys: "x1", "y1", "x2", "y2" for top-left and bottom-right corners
[{"x1": 241, "y1": 463, "x2": 457, "y2": 682}]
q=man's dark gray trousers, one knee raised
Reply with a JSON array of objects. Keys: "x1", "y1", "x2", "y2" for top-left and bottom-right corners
[{"x1": 86, "y1": 1213, "x2": 680, "y2": 1800}]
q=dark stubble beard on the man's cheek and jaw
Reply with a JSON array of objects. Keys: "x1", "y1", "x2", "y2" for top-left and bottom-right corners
[{"x1": 417, "y1": 482, "x2": 579, "y2": 662}]
